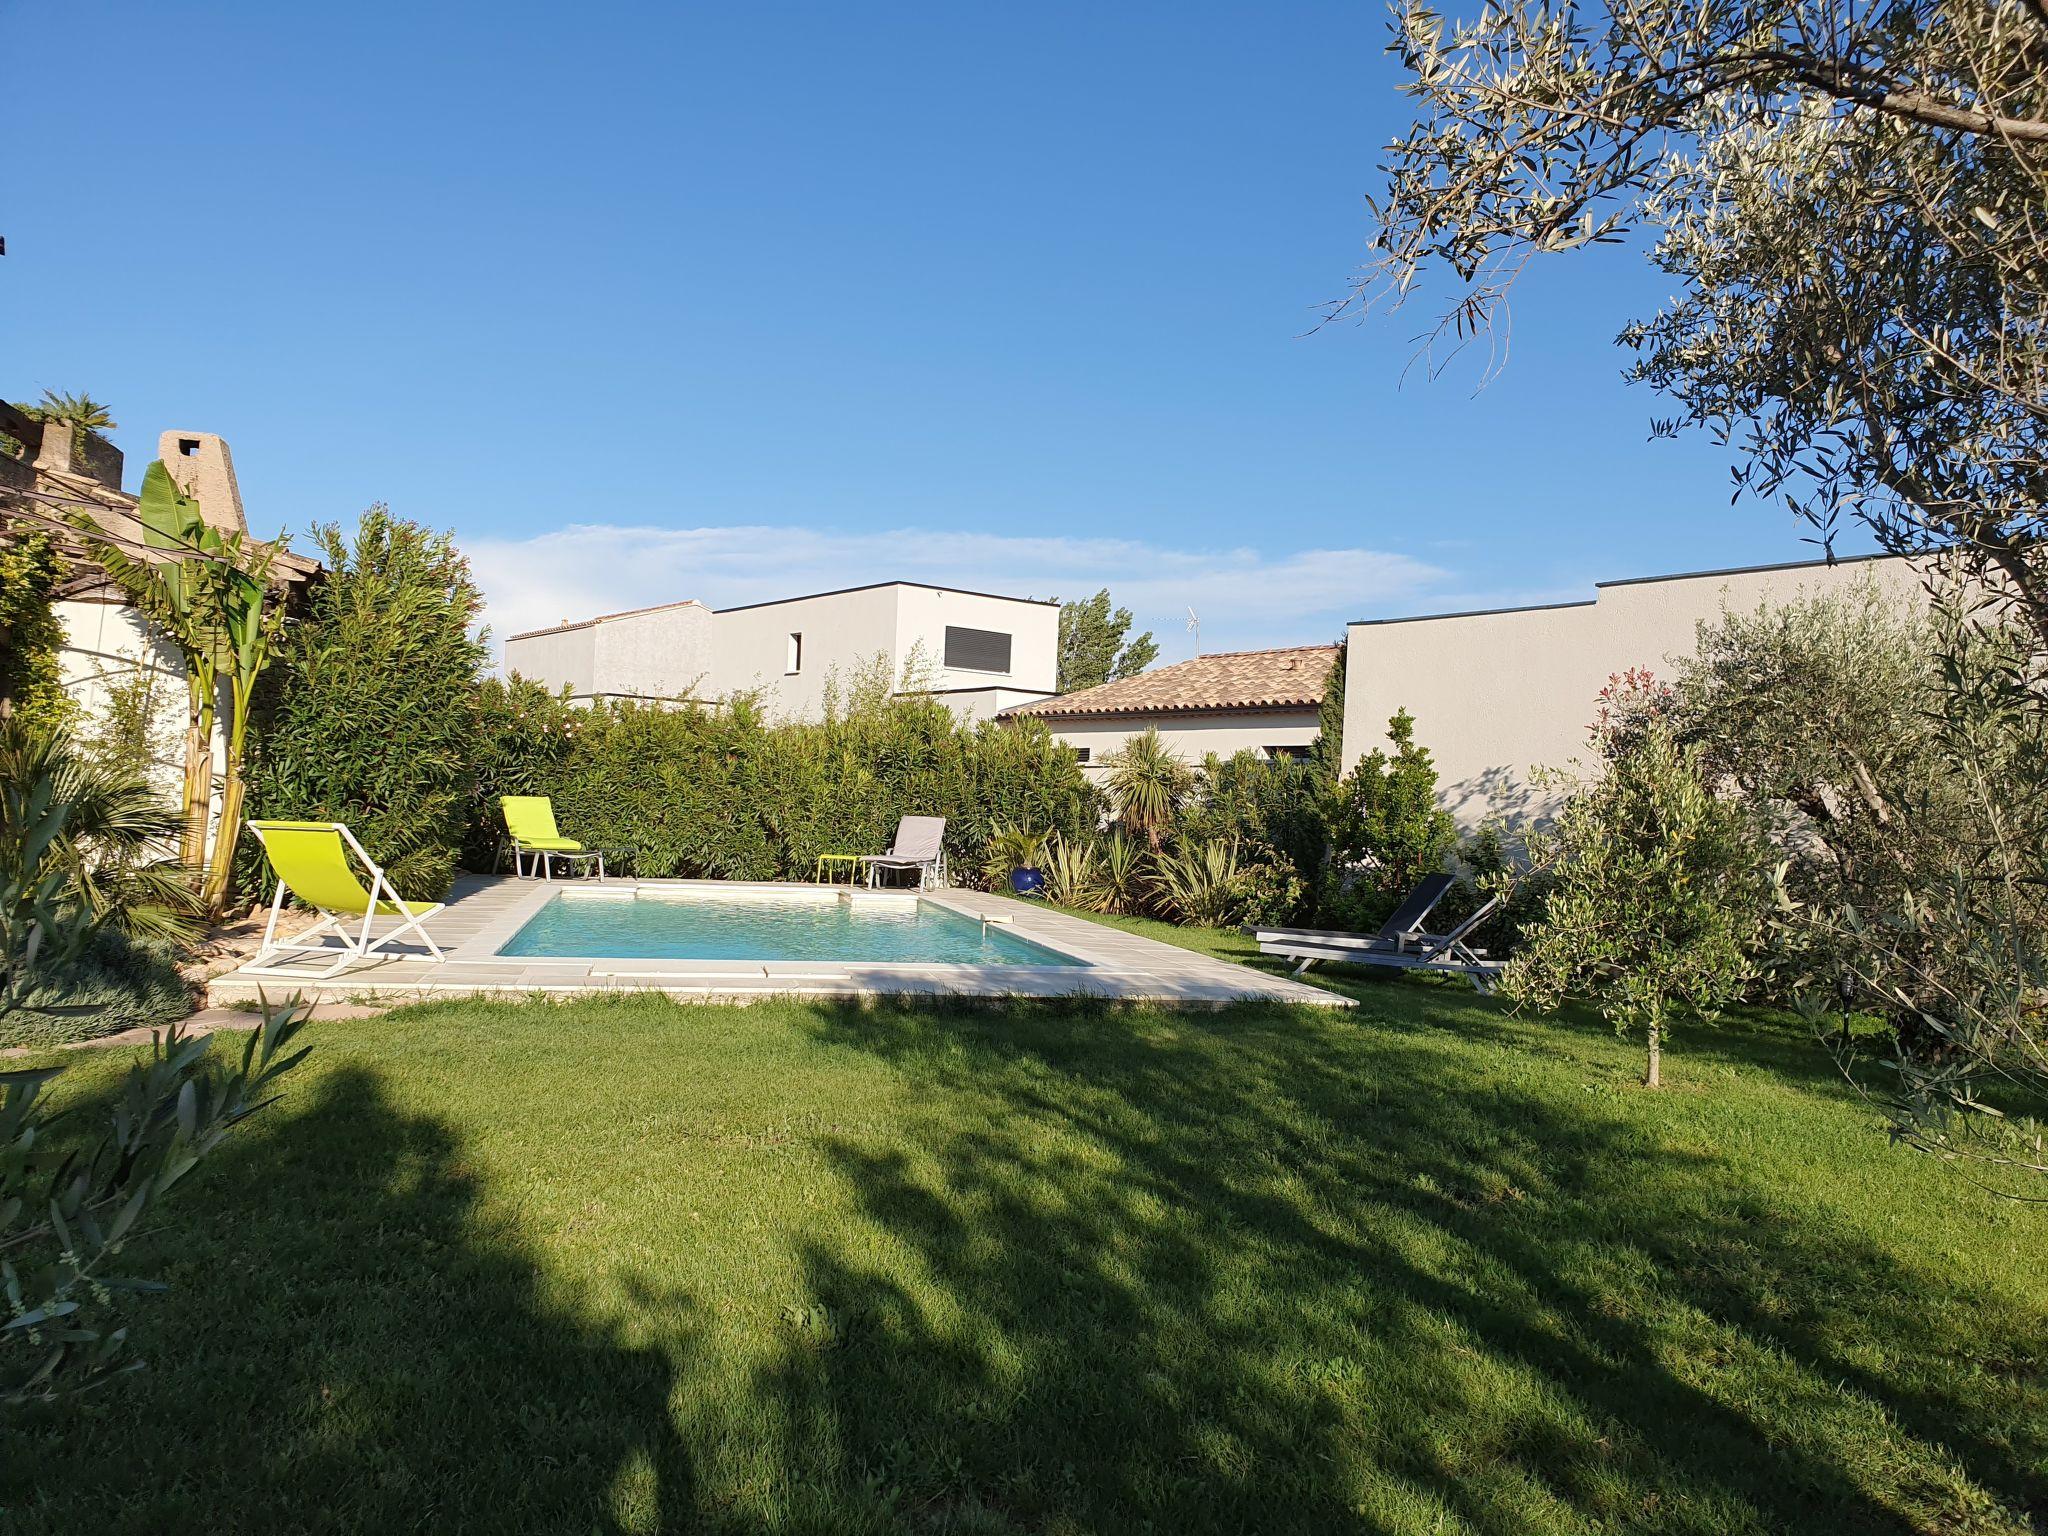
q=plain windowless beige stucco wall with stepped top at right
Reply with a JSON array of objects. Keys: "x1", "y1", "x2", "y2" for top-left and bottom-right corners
[{"x1": 1343, "y1": 557, "x2": 1923, "y2": 827}]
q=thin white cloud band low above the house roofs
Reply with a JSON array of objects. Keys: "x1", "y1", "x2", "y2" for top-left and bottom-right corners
[{"x1": 463, "y1": 524, "x2": 1450, "y2": 659}]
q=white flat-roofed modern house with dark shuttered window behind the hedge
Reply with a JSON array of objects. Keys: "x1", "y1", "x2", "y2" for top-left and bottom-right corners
[{"x1": 504, "y1": 582, "x2": 1059, "y2": 721}]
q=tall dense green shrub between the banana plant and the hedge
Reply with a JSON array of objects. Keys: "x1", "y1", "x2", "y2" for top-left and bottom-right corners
[{"x1": 252, "y1": 506, "x2": 485, "y2": 901}]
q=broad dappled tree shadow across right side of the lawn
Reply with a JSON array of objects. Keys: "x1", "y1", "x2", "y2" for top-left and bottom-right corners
[{"x1": 760, "y1": 1006, "x2": 2048, "y2": 1532}]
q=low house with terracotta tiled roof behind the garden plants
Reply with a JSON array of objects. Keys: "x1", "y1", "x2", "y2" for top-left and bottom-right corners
[{"x1": 1004, "y1": 645, "x2": 1337, "y2": 770}]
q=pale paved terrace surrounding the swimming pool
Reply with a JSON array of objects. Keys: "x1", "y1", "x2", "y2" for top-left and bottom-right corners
[{"x1": 207, "y1": 877, "x2": 1352, "y2": 1008}]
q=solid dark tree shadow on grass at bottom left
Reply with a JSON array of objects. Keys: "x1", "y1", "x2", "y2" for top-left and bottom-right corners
[{"x1": 0, "y1": 1067, "x2": 694, "y2": 1534}]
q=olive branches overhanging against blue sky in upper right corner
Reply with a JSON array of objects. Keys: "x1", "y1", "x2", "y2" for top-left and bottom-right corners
[{"x1": 1356, "y1": 0, "x2": 2048, "y2": 637}]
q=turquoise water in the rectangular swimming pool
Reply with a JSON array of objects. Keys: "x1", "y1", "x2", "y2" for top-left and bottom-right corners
[{"x1": 498, "y1": 891, "x2": 1087, "y2": 967}]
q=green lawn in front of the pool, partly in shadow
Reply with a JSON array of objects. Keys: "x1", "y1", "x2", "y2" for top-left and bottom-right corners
[{"x1": 0, "y1": 958, "x2": 2048, "y2": 1536}]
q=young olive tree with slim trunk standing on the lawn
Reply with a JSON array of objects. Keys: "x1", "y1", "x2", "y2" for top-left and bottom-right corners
[{"x1": 1499, "y1": 723, "x2": 1769, "y2": 1087}]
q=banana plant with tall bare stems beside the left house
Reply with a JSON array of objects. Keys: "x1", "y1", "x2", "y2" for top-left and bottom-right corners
[{"x1": 82, "y1": 459, "x2": 285, "y2": 913}]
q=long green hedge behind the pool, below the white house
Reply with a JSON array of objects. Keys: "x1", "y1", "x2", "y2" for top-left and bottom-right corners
[{"x1": 465, "y1": 680, "x2": 1102, "y2": 881}]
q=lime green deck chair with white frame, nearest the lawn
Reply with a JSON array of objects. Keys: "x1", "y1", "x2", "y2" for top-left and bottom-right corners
[{"x1": 242, "y1": 821, "x2": 449, "y2": 981}]
